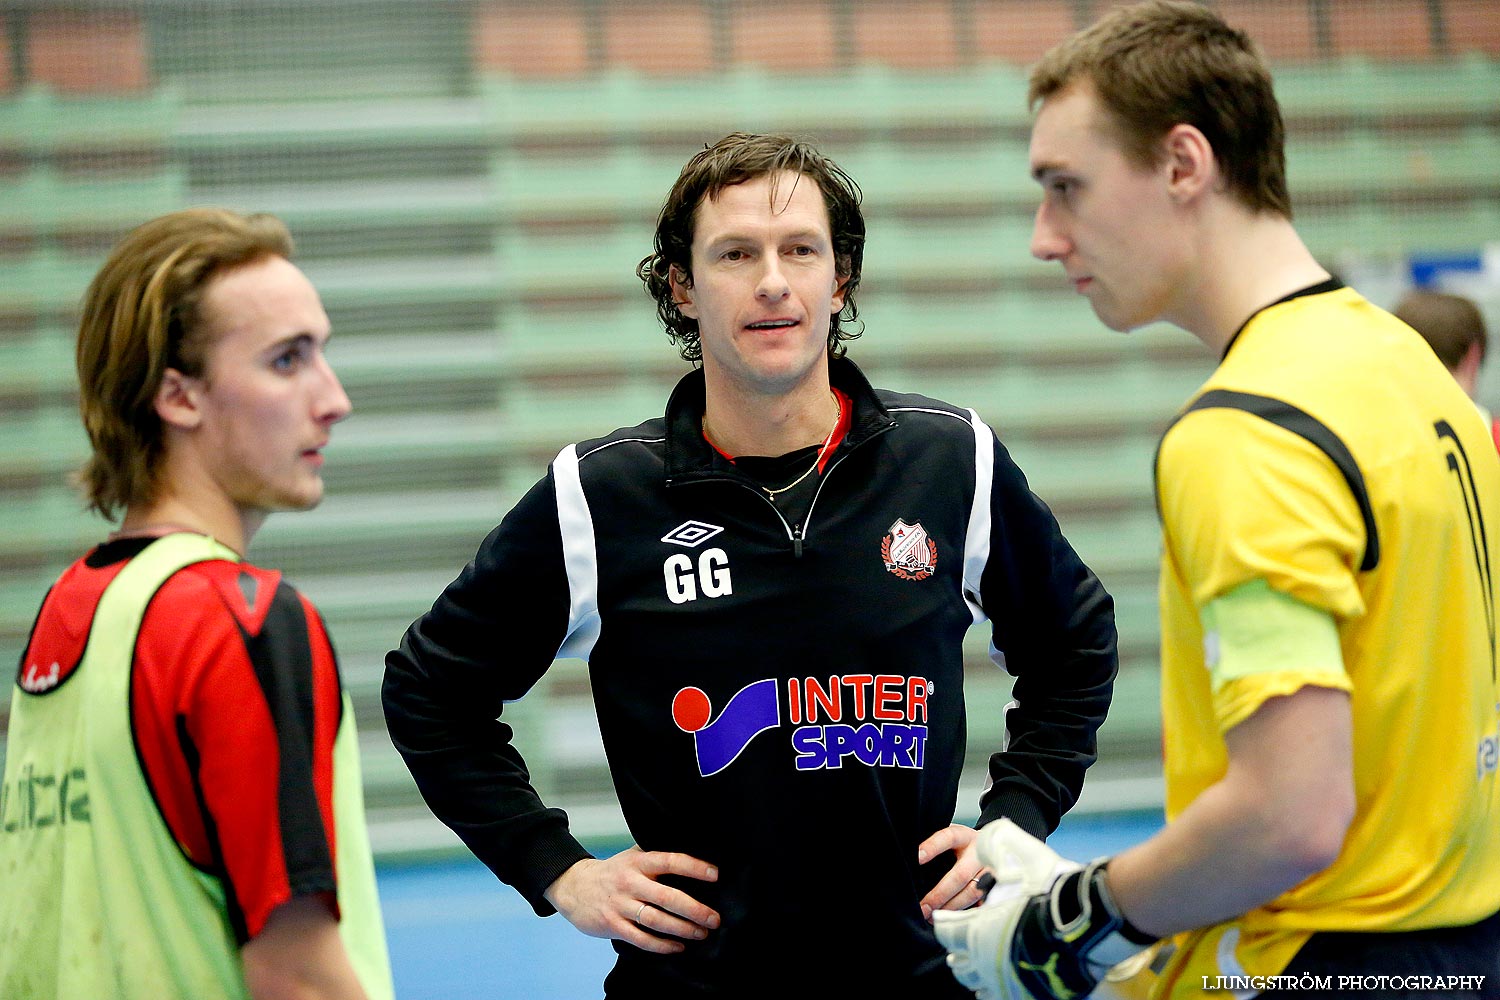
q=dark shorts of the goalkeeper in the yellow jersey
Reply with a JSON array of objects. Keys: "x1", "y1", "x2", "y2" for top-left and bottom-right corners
[{"x1": 1263, "y1": 913, "x2": 1500, "y2": 1000}]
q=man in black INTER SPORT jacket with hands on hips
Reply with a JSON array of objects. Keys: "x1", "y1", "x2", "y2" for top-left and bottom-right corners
[{"x1": 384, "y1": 133, "x2": 1118, "y2": 997}]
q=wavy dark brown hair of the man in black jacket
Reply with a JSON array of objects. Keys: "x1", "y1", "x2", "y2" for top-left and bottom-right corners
[{"x1": 636, "y1": 132, "x2": 864, "y2": 363}]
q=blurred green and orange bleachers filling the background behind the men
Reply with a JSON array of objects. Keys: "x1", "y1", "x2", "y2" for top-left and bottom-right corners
[{"x1": 0, "y1": 0, "x2": 1500, "y2": 858}]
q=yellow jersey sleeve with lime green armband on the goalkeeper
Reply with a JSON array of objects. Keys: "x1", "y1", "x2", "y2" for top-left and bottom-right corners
[{"x1": 1157, "y1": 408, "x2": 1365, "y2": 732}]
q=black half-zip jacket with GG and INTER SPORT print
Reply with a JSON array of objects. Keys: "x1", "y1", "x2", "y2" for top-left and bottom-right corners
[{"x1": 384, "y1": 360, "x2": 1118, "y2": 997}]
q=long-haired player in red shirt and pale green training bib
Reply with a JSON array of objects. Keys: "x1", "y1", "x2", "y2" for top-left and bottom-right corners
[{"x1": 0, "y1": 208, "x2": 393, "y2": 1000}]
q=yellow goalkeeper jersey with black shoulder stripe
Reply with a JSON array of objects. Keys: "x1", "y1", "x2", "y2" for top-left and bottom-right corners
[{"x1": 1157, "y1": 282, "x2": 1500, "y2": 996}]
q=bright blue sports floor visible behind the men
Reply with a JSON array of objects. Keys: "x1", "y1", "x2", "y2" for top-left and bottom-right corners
[{"x1": 378, "y1": 813, "x2": 1161, "y2": 1000}]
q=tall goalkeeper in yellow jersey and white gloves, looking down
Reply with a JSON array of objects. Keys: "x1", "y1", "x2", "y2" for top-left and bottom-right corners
[{"x1": 938, "y1": 0, "x2": 1500, "y2": 997}]
